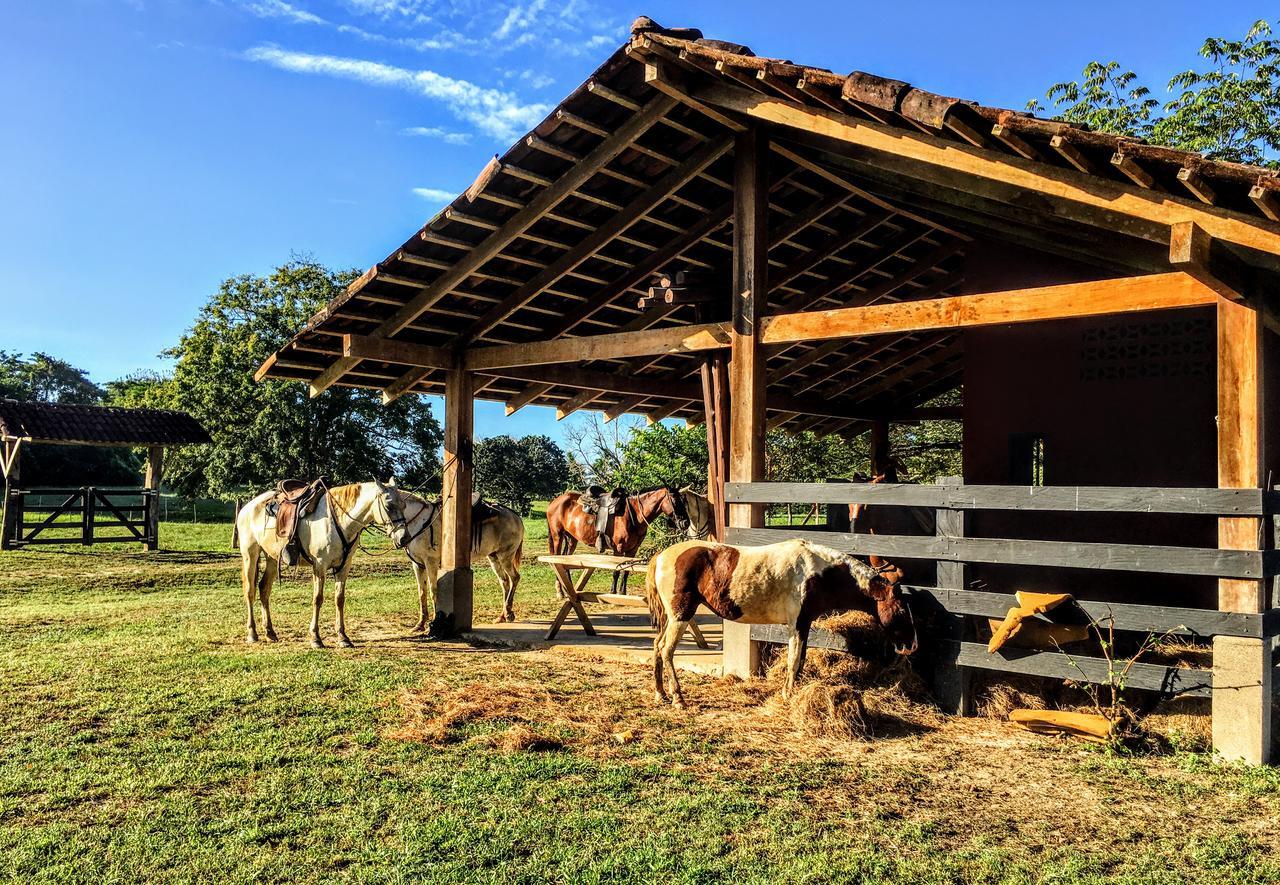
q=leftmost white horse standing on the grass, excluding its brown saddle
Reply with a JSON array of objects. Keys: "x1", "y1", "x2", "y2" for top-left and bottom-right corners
[{"x1": 236, "y1": 482, "x2": 408, "y2": 648}]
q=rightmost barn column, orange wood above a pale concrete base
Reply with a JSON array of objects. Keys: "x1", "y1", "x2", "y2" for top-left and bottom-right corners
[{"x1": 1213, "y1": 297, "x2": 1271, "y2": 765}]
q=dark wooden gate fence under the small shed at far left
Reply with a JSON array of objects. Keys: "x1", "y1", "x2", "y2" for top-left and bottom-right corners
[{"x1": 4, "y1": 485, "x2": 159, "y2": 549}]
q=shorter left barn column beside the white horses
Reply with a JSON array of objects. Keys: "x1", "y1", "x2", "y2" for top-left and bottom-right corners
[{"x1": 431, "y1": 369, "x2": 475, "y2": 635}]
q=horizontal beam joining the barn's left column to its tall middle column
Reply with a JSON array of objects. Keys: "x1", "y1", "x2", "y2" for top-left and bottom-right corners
[{"x1": 463, "y1": 323, "x2": 730, "y2": 371}]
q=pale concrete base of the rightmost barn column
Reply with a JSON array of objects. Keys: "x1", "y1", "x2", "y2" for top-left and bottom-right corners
[{"x1": 1213, "y1": 637, "x2": 1272, "y2": 765}]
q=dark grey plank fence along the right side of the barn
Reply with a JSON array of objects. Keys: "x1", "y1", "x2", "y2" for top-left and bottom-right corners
[{"x1": 726, "y1": 480, "x2": 1280, "y2": 712}]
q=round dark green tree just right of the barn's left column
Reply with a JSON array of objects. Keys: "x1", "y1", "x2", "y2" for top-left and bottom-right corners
[{"x1": 474, "y1": 434, "x2": 570, "y2": 516}]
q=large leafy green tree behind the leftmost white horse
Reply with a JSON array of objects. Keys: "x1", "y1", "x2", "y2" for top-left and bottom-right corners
[{"x1": 162, "y1": 257, "x2": 443, "y2": 498}]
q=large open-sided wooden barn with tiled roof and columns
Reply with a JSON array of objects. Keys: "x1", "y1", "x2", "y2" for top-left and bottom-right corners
[{"x1": 260, "y1": 18, "x2": 1280, "y2": 762}]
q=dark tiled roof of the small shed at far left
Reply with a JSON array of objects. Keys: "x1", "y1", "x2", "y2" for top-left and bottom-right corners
[{"x1": 0, "y1": 400, "x2": 212, "y2": 446}]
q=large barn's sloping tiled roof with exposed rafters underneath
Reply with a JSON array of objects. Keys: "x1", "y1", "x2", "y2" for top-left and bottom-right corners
[{"x1": 259, "y1": 18, "x2": 1280, "y2": 434}]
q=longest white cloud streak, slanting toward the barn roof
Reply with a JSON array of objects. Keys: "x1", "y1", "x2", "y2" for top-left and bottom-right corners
[{"x1": 244, "y1": 46, "x2": 550, "y2": 141}]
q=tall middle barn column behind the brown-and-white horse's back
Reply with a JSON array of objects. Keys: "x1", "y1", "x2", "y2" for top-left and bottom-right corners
[{"x1": 724, "y1": 127, "x2": 769, "y2": 679}]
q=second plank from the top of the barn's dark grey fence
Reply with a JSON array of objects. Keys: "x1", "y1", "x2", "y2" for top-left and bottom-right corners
[{"x1": 728, "y1": 528, "x2": 1275, "y2": 580}]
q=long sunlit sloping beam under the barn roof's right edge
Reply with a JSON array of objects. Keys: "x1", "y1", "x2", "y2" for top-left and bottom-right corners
[{"x1": 692, "y1": 83, "x2": 1280, "y2": 261}]
